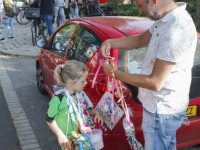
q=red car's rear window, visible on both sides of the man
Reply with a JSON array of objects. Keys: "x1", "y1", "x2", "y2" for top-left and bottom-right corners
[{"x1": 118, "y1": 40, "x2": 200, "y2": 99}]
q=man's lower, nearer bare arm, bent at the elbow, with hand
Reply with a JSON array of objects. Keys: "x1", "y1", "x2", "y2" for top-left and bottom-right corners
[{"x1": 104, "y1": 58, "x2": 176, "y2": 91}]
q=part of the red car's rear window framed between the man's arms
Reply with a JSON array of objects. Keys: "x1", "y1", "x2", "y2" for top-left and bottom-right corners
[{"x1": 118, "y1": 46, "x2": 147, "y2": 74}]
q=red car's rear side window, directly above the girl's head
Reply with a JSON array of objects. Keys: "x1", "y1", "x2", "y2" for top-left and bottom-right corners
[{"x1": 67, "y1": 25, "x2": 102, "y2": 63}]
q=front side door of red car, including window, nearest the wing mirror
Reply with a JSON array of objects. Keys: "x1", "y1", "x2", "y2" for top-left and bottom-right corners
[{"x1": 42, "y1": 24, "x2": 76, "y2": 91}]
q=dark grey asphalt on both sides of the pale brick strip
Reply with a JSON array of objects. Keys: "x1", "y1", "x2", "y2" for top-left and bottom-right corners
[{"x1": 0, "y1": 57, "x2": 200, "y2": 150}]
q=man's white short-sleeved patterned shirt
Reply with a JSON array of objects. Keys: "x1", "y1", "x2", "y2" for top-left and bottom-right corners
[{"x1": 138, "y1": 3, "x2": 197, "y2": 114}]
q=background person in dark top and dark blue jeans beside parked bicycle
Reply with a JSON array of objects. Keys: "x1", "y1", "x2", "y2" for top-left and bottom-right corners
[{"x1": 30, "y1": 0, "x2": 54, "y2": 36}]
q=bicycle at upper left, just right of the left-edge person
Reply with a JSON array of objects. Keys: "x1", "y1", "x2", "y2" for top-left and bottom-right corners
[{"x1": 15, "y1": 3, "x2": 30, "y2": 25}]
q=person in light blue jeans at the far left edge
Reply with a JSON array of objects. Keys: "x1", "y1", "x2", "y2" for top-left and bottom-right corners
[{"x1": 0, "y1": 0, "x2": 15, "y2": 41}]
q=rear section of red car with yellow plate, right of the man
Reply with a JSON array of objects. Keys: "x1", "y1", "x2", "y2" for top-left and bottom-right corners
[{"x1": 176, "y1": 42, "x2": 200, "y2": 148}]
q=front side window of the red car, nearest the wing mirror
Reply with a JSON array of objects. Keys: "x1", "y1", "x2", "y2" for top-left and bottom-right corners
[{"x1": 51, "y1": 24, "x2": 76, "y2": 57}]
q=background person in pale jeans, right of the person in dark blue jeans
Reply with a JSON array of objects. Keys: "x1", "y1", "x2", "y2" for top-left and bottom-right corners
[{"x1": 54, "y1": 0, "x2": 65, "y2": 25}]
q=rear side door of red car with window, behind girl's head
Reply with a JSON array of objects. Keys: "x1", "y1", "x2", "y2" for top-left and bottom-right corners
[{"x1": 66, "y1": 24, "x2": 106, "y2": 96}]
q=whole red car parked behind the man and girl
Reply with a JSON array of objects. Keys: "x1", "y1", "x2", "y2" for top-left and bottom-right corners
[{"x1": 36, "y1": 16, "x2": 200, "y2": 150}]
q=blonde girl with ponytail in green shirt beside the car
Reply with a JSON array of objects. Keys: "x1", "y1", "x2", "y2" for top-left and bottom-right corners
[{"x1": 47, "y1": 60, "x2": 103, "y2": 150}]
